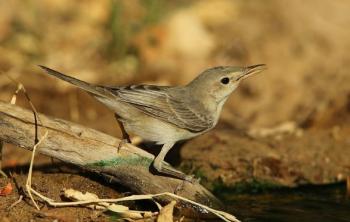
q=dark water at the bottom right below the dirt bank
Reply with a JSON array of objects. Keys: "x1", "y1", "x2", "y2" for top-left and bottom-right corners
[{"x1": 223, "y1": 185, "x2": 350, "y2": 222}]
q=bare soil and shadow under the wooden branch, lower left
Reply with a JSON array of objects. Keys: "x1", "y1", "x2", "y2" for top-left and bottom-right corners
[{"x1": 0, "y1": 152, "x2": 121, "y2": 221}]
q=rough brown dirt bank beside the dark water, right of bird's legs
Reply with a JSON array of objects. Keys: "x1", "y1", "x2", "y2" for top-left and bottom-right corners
[{"x1": 181, "y1": 127, "x2": 350, "y2": 189}]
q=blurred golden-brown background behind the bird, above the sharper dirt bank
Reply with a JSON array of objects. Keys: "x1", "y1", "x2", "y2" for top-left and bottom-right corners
[{"x1": 0, "y1": 0, "x2": 350, "y2": 131}]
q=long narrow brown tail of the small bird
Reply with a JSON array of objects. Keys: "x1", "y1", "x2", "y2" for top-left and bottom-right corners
[{"x1": 39, "y1": 65, "x2": 107, "y2": 97}]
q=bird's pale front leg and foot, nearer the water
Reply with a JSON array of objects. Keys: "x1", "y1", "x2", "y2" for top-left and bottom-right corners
[{"x1": 153, "y1": 143, "x2": 192, "y2": 182}]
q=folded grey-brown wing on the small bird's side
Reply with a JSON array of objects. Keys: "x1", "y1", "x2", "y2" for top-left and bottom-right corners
[{"x1": 108, "y1": 85, "x2": 214, "y2": 132}]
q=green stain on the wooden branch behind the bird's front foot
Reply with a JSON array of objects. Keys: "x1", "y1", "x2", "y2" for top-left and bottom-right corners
[{"x1": 88, "y1": 156, "x2": 153, "y2": 167}]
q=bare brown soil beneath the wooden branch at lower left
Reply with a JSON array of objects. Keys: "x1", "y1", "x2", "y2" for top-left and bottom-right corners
[{"x1": 0, "y1": 170, "x2": 120, "y2": 221}]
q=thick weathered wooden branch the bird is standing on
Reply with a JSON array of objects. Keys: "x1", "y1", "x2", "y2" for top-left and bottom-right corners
[{"x1": 0, "y1": 101, "x2": 221, "y2": 216}]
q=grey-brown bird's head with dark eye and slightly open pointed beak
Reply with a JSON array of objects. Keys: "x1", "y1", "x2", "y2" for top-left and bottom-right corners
[{"x1": 188, "y1": 64, "x2": 266, "y2": 103}]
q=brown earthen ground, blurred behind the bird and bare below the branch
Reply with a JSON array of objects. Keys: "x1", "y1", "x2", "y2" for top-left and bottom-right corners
[{"x1": 0, "y1": 0, "x2": 350, "y2": 222}]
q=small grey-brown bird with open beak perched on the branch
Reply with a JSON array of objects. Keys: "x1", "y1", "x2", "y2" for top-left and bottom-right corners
[{"x1": 39, "y1": 64, "x2": 267, "y2": 181}]
